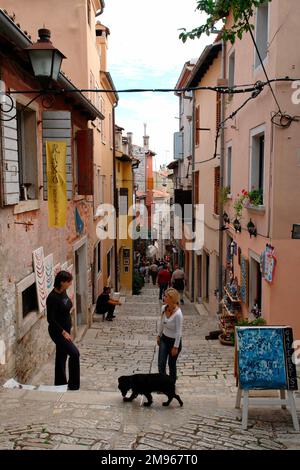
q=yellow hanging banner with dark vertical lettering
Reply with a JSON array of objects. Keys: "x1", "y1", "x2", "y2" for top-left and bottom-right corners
[{"x1": 46, "y1": 141, "x2": 67, "y2": 227}]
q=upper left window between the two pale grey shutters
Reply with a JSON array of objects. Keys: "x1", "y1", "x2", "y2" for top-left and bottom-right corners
[{"x1": 17, "y1": 104, "x2": 38, "y2": 201}]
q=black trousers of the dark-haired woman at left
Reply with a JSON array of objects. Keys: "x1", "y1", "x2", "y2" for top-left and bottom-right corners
[{"x1": 50, "y1": 335, "x2": 80, "y2": 390}]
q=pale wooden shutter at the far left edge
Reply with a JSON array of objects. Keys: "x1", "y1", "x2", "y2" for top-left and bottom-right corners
[{"x1": 1, "y1": 98, "x2": 20, "y2": 205}]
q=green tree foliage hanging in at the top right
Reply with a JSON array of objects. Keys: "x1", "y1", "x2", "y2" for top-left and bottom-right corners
[{"x1": 179, "y1": 0, "x2": 272, "y2": 43}]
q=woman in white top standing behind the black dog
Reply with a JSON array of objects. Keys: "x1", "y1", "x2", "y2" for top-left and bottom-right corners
[{"x1": 157, "y1": 287, "x2": 183, "y2": 383}]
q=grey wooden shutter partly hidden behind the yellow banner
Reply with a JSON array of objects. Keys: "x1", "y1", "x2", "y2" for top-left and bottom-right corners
[{"x1": 43, "y1": 111, "x2": 73, "y2": 200}]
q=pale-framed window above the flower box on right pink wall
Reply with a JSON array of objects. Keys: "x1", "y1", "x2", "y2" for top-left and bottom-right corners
[{"x1": 249, "y1": 126, "x2": 265, "y2": 204}]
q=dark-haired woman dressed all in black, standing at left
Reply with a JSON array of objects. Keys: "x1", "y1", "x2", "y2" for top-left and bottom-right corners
[{"x1": 46, "y1": 271, "x2": 80, "y2": 390}]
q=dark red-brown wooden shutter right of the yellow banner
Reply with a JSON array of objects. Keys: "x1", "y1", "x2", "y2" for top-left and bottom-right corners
[{"x1": 76, "y1": 129, "x2": 94, "y2": 196}]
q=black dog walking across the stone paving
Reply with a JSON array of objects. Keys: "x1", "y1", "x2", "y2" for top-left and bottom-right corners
[{"x1": 118, "y1": 374, "x2": 183, "y2": 406}]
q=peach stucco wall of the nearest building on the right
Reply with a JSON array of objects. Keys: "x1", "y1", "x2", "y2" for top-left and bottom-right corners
[{"x1": 225, "y1": 0, "x2": 300, "y2": 338}]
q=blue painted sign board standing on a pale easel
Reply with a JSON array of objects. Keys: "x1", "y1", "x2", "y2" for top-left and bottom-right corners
[{"x1": 236, "y1": 326, "x2": 299, "y2": 431}]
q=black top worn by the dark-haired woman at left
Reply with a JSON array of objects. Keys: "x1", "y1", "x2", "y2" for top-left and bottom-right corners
[{"x1": 47, "y1": 289, "x2": 72, "y2": 336}]
